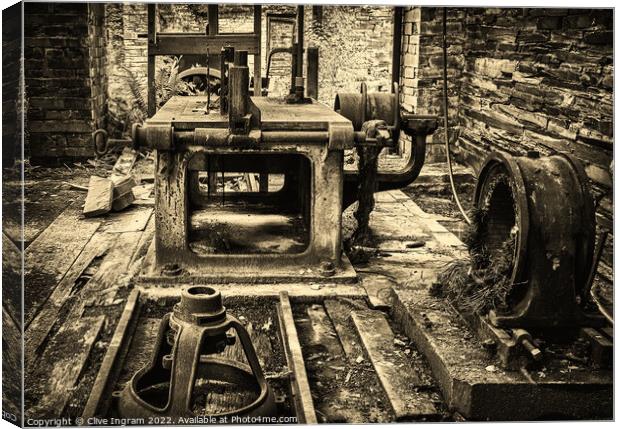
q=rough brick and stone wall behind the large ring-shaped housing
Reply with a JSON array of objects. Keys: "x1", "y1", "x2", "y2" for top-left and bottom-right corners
[{"x1": 402, "y1": 8, "x2": 613, "y2": 288}]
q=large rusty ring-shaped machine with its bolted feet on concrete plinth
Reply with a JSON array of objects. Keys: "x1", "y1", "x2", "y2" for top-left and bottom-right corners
[{"x1": 460, "y1": 151, "x2": 611, "y2": 367}]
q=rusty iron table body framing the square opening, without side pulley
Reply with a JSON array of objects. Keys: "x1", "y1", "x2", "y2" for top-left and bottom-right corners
[{"x1": 134, "y1": 51, "x2": 358, "y2": 277}]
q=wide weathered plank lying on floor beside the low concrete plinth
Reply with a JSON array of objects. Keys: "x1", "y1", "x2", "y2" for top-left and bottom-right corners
[{"x1": 351, "y1": 310, "x2": 438, "y2": 420}]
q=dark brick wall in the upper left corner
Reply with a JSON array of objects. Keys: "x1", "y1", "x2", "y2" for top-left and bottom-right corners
[{"x1": 24, "y1": 3, "x2": 107, "y2": 163}]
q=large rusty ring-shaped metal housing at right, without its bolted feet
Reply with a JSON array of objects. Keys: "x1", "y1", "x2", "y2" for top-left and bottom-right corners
[{"x1": 475, "y1": 153, "x2": 601, "y2": 328}]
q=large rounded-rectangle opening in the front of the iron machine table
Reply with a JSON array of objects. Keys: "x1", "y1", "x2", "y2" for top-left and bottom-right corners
[{"x1": 188, "y1": 154, "x2": 312, "y2": 255}]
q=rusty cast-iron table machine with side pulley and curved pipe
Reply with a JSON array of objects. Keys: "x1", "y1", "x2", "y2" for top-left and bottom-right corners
[{"x1": 133, "y1": 5, "x2": 437, "y2": 283}]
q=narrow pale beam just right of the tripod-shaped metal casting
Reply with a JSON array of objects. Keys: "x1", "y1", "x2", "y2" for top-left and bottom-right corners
[{"x1": 278, "y1": 292, "x2": 318, "y2": 424}]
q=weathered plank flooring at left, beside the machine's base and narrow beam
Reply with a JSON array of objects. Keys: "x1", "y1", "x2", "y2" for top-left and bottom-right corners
[{"x1": 24, "y1": 206, "x2": 154, "y2": 418}]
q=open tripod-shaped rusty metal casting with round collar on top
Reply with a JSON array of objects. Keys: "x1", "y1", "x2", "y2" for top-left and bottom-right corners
[{"x1": 119, "y1": 286, "x2": 276, "y2": 422}]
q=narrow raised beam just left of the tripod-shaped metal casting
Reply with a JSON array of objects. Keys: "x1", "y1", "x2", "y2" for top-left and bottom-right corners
[{"x1": 82, "y1": 289, "x2": 140, "y2": 420}]
